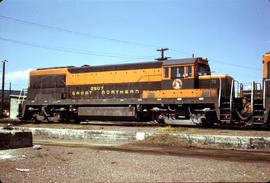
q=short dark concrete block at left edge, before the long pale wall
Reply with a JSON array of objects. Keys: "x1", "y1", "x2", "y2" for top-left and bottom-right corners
[{"x1": 0, "y1": 128, "x2": 33, "y2": 150}]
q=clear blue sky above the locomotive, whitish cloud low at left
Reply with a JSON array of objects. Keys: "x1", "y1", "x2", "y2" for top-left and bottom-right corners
[{"x1": 0, "y1": 0, "x2": 270, "y2": 89}]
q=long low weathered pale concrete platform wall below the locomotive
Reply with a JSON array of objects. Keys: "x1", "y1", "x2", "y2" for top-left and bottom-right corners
[{"x1": 20, "y1": 128, "x2": 270, "y2": 151}]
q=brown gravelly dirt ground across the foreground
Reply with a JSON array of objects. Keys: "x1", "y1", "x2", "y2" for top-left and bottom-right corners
[{"x1": 0, "y1": 144, "x2": 270, "y2": 183}]
